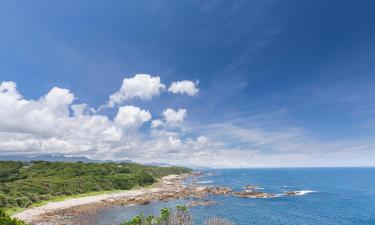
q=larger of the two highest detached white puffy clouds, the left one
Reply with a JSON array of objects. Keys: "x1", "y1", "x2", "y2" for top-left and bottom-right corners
[{"x1": 108, "y1": 74, "x2": 165, "y2": 107}]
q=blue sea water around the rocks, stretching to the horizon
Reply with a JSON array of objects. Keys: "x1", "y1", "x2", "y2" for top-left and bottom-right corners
[{"x1": 93, "y1": 168, "x2": 375, "y2": 225}]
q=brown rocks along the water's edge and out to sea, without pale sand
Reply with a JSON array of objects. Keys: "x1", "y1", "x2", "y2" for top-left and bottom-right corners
[{"x1": 27, "y1": 173, "x2": 311, "y2": 224}]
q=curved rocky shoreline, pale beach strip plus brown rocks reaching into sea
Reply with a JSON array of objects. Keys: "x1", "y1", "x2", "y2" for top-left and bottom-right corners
[{"x1": 14, "y1": 173, "x2": 312, "y2": 225}]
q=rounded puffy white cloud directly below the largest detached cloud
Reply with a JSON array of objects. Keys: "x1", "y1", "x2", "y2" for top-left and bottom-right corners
[{"x1": 115, "y1": 106, "x2": 151, "y2": 128}]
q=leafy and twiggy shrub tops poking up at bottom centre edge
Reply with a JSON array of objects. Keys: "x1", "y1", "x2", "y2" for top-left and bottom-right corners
[{"x1": 121, "y1": 206, "x2": 235, "y2": 225}]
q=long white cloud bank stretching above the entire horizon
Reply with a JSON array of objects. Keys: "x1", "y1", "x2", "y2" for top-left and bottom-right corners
[{"x1": 0, "y1": 82, "x2": 375, "y2": 167}]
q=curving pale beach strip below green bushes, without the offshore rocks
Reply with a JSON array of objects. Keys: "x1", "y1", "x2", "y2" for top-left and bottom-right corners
[{"x1": 12, "y1": 174, "x2": 194, "y2": 225}]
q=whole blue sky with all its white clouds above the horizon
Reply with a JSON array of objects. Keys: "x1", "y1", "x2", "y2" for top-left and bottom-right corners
[{"x1": 0, "y1": 0, "x2": 375, "y2": 168}]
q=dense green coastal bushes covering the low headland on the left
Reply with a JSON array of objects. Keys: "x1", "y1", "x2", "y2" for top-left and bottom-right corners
[{"x1": 0, "y1": 161, "x2": 190, "y2": 208}]
